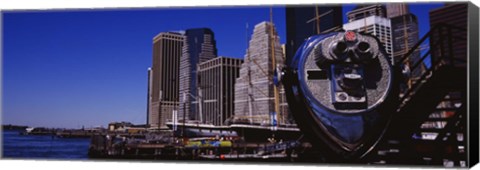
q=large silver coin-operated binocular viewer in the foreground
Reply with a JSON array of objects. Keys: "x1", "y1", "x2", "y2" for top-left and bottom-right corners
[{"x1": 282, "y1": 31, "x2": 398, "y2": 160}]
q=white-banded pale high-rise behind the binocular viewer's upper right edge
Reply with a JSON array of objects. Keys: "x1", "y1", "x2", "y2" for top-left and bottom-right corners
[{"x1": 343, "y1": 5, "x2": 393, "y2": 60}]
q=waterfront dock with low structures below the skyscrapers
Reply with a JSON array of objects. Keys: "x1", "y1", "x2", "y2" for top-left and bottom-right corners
[{"x1": 89, "y1": 134, "x2": 311, "y2": 161}]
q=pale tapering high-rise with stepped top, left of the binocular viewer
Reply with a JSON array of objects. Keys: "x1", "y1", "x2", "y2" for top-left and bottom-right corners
[{"x1": 234, "y1": 22, "x2": 288, "y2": 125}]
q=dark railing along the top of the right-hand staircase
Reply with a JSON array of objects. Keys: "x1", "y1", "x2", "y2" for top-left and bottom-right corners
[{"x1": 395, "y1": 24, "x2": 467, "y2": 109}]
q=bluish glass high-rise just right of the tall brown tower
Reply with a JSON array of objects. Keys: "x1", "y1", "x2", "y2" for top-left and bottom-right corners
[{"x1": 178, "y1": 28, "x2": 217, "y2": 120}]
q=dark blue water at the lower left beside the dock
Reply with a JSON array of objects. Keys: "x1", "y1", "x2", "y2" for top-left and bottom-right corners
[{"x1": 2, "y1": 130, "x2": 90, "y2": 160}]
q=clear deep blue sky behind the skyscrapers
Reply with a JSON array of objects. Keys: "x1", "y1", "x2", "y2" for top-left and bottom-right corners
[{"x1": 2, "y1": 4, "x2": 440, "y2": 128}]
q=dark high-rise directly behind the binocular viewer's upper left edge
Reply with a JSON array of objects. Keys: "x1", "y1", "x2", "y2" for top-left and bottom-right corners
[{"x1": 285, "y1": 5, "x2": 343, "y2": 62}]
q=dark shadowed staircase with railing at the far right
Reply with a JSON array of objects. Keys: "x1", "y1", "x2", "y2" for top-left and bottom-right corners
[{"x1": 366, "y1": 22, "x2": 467, "y2": 167}]
